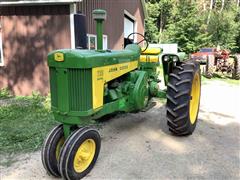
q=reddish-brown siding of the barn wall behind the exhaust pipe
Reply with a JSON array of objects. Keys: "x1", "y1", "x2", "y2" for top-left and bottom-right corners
[{"x1": 77, "y1": 0, "x2": 144, "y2": 49}]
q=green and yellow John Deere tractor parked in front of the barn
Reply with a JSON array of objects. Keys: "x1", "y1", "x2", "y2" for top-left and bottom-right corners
[{"x1": 42, "y1": 9, "x2": 201, "y2": 179}]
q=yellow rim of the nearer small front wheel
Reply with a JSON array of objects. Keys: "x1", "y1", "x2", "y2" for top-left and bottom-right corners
[{"x1": 73, "y1": 139, "x2": 96, "y2": 173}]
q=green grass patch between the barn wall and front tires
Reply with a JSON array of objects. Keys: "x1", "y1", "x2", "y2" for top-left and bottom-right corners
[{"x1": 0, "y1": 94, "x2": 57, "y2": 166}]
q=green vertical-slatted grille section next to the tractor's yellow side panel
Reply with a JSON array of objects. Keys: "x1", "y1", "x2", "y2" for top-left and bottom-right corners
[{"x1": 68, "y1": 69, "x2": 92, "y2": 111}]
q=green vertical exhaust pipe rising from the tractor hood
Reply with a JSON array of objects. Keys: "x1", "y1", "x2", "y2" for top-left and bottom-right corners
[{"x1": 92, "y1": 9, "x2": 107, "y2": 51}]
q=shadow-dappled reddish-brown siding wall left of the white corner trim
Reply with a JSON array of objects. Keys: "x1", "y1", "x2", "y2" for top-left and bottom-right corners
[{"x1": 0, "y1": 6, "x2": 70, "y2": 95}]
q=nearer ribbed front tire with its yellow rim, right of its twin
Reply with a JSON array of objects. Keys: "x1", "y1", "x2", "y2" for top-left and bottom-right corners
[{"x1": 59, "y1": 128, "x2": 101, "y2": 180}]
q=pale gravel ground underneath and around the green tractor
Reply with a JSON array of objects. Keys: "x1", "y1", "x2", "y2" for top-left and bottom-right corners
[{"x1": 0, "y1": 81, "x2": 240, "y2": 180}]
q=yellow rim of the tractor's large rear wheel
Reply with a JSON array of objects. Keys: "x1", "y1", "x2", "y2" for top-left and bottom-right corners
[{"x1": 189, "y1": 73, "x2": 200, "y2": 124}]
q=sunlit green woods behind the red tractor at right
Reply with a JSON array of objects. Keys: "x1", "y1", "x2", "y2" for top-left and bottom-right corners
[{"x1": 146, "y1": 0, "x2": 240, "y2": 53}]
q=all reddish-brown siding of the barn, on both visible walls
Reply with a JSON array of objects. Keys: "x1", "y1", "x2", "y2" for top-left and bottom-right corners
[{"x1": 0, "y1": 0, "x2": 144, "y2": 95}]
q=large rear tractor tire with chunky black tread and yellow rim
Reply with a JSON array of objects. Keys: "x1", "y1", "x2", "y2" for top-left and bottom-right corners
[{"x1": 166, "y1": 61, "x2": 201, "y2": 136}]
